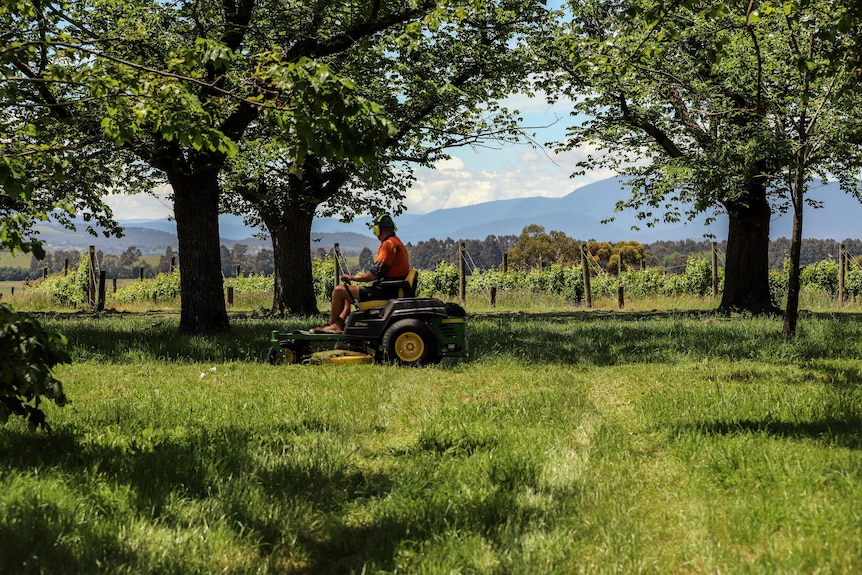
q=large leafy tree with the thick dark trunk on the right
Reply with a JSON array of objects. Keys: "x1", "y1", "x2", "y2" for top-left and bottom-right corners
[{"x1": 542, "y1": 0, "x2": 808, "y2": 313}]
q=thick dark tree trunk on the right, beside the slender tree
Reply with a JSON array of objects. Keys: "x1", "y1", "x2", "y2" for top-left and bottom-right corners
[{"x1": 718, "y1": 182, "x2": 780, "y2": 315}]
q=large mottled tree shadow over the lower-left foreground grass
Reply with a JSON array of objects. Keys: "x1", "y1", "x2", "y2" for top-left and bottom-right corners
[{"x1": 0, "y1": 423, "x2": 560, "y2": 574}]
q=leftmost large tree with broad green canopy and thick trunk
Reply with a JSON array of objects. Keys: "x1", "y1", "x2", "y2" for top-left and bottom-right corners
[{"x1": 3, "y1": 0, "x2": 437, "y2": 333}]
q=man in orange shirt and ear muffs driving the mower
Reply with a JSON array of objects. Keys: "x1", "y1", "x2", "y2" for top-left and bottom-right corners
[{"x1": 309, "y1": 214, "x2": 410, "y2": 333}]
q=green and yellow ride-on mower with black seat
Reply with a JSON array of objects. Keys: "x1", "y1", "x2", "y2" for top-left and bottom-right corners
[{"x1": 269, "y1": 270, "x2": 467, "y2": 366}]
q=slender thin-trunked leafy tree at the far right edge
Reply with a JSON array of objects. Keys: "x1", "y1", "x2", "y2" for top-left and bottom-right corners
[{"x1": 764, "y1": 2, "x2": 862, "y2": 338}]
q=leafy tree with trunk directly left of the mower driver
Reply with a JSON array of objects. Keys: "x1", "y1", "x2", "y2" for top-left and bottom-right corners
[{"x1": 221, "y1": 0, "x2": 544, "y2": 313}]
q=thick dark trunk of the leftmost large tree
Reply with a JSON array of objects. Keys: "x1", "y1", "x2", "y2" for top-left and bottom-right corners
[{"x1": 168, "y1": 169, "x2": 230, "y2": 334}]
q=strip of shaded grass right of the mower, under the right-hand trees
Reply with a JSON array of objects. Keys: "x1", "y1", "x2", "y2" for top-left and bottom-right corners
[{"x1": 468, "y1": 311, "x2": 862, "y2": 366}]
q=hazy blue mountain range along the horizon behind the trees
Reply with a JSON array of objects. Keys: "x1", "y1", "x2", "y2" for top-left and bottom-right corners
[{"x1": 28, "y1": 178, "x2": 862, "y2": 254}]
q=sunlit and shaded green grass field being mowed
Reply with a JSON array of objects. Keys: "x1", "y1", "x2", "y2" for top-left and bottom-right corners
[{"x1": 0, "y1": 302, "x2": 862, "y2": 574}]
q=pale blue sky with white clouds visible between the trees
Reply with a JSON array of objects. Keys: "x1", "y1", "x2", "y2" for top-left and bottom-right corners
[{"x1": 108, "y1": 96, "x2": 614, "y2": 220}]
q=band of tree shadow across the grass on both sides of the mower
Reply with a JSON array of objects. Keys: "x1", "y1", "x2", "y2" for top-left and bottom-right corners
[{"x1": 27, "y1": 310, "x2": 862, "y2": 366}]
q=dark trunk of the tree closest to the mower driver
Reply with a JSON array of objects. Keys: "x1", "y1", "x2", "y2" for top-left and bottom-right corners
[{"x1": 261, "y1": 208, "x2": 320, "y2": 315}]
